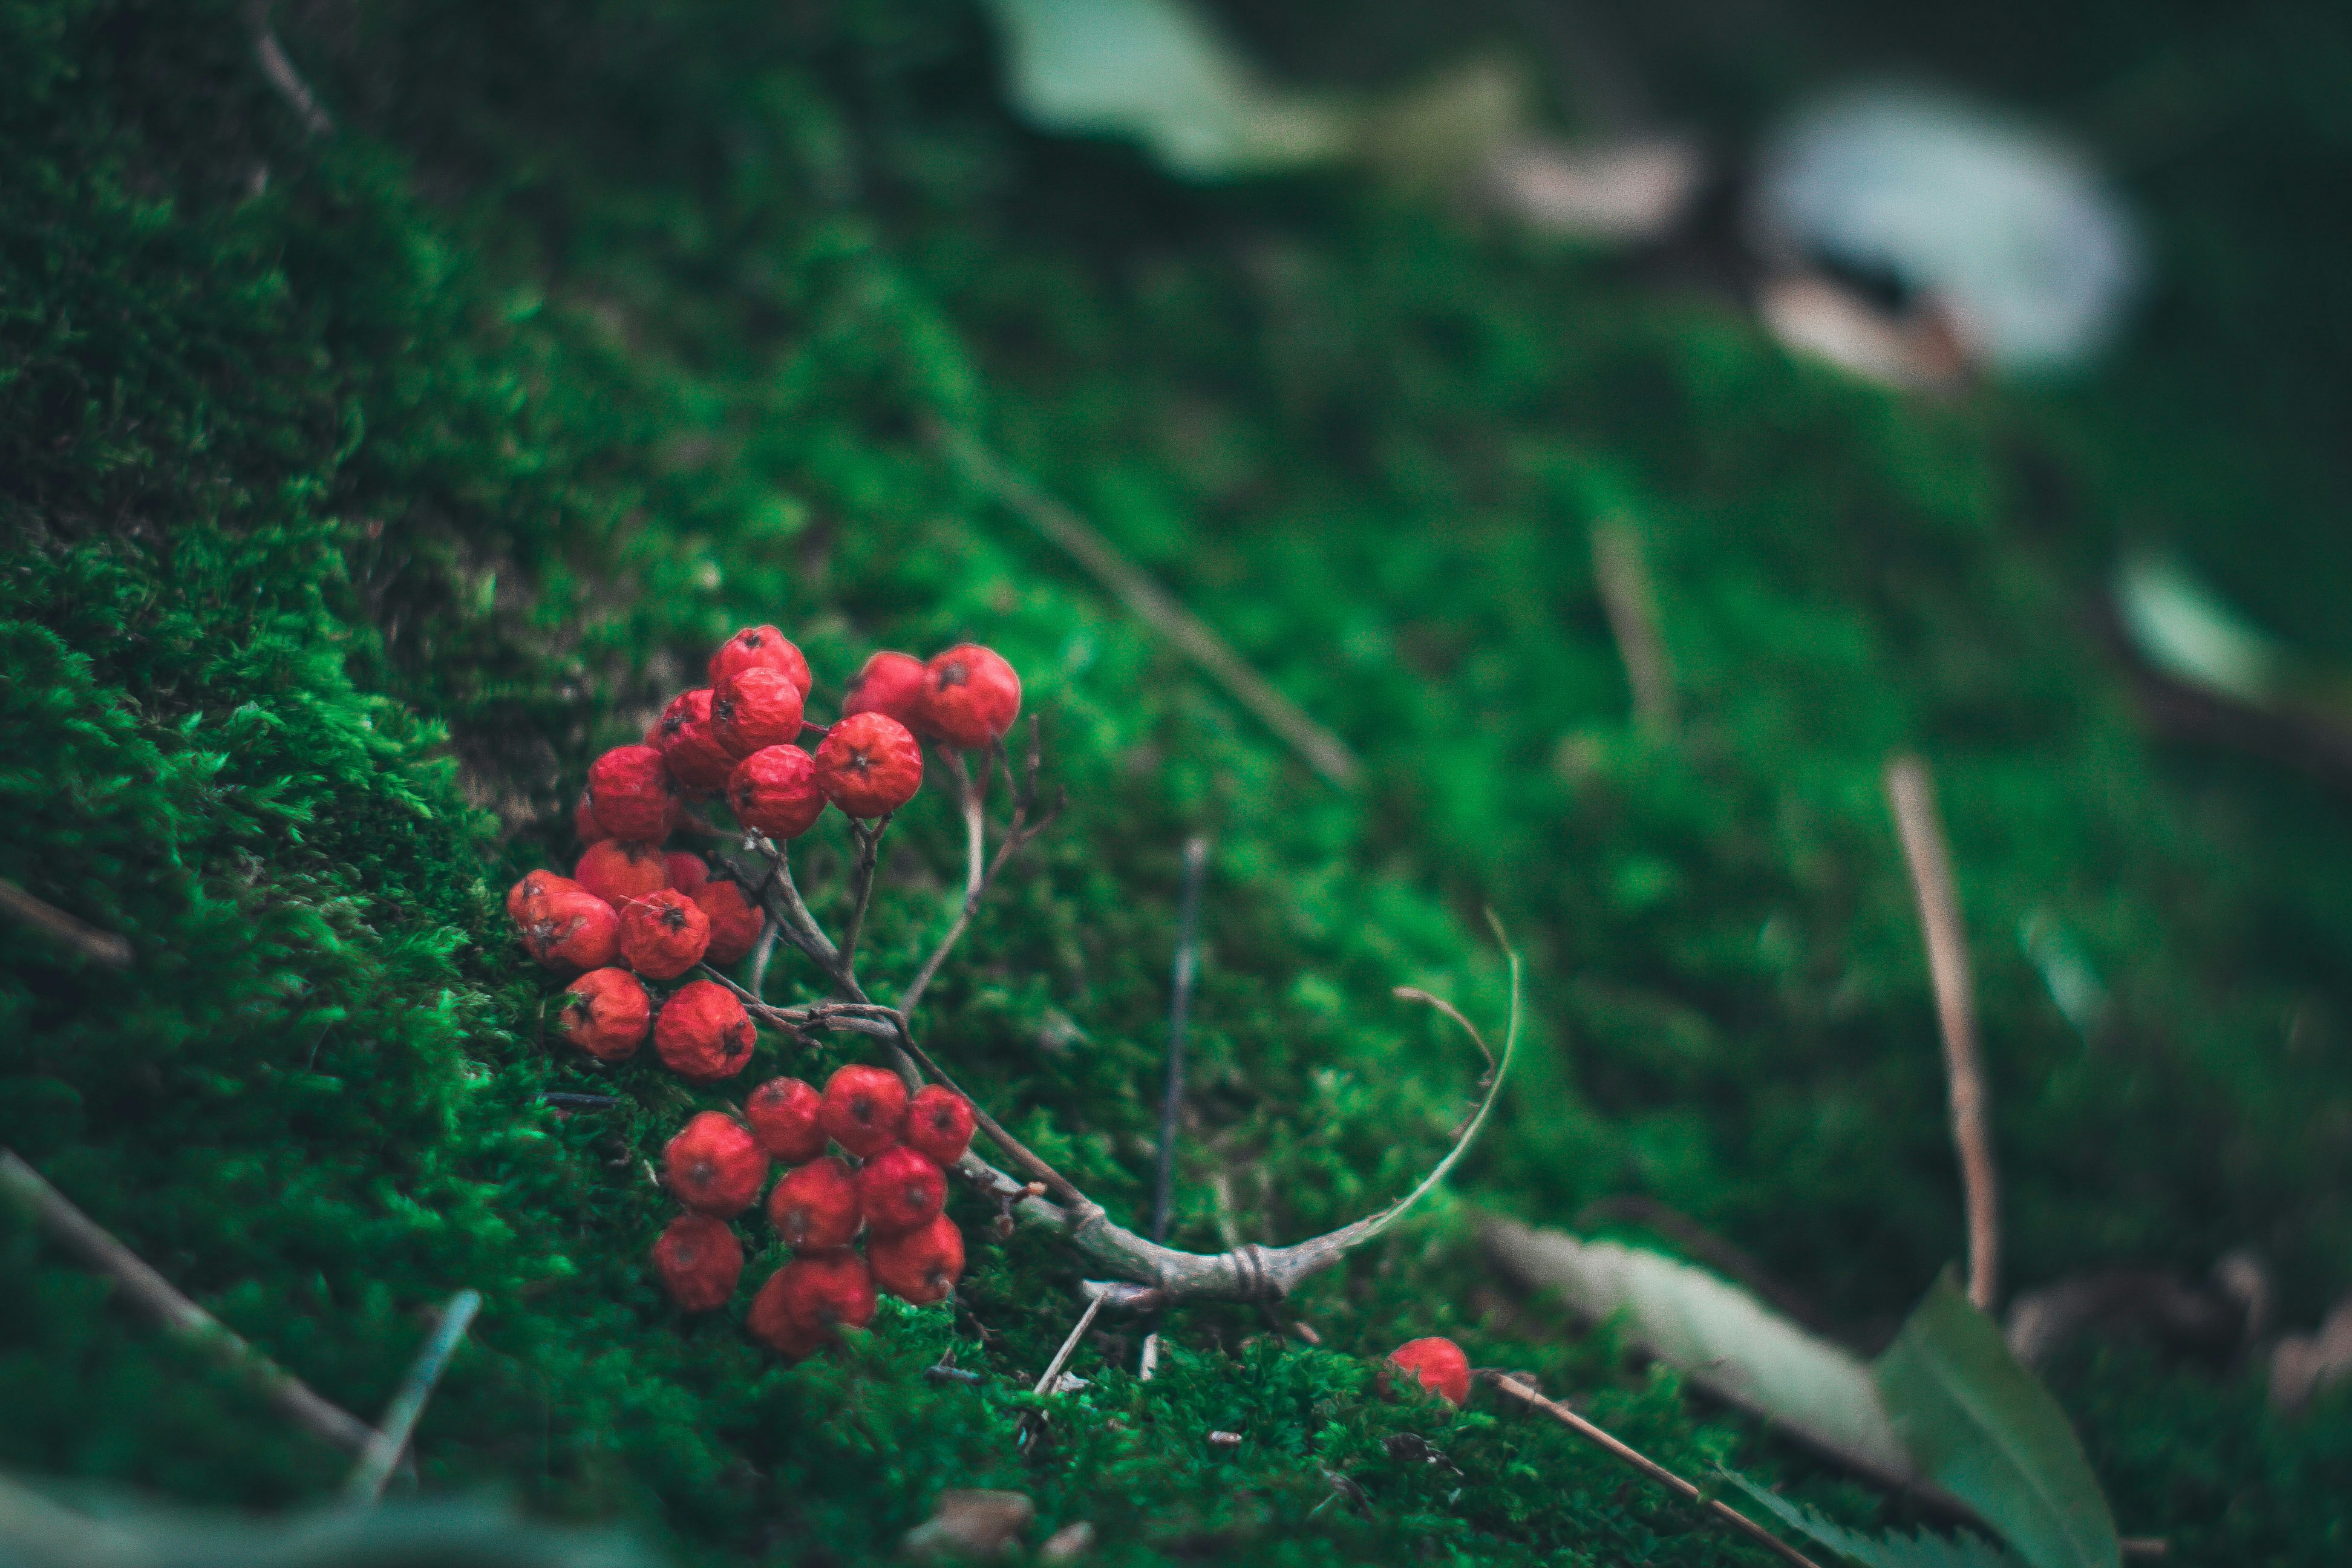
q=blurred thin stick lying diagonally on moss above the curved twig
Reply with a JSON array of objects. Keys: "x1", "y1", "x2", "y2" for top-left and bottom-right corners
[{"x1": 932, "y1": 425, "x2": 1364, "y2": 790}]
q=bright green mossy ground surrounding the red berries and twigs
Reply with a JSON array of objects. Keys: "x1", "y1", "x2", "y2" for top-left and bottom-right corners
[{"x1": 0, "y1": 0, "x2": 2352, "y2": 1563}]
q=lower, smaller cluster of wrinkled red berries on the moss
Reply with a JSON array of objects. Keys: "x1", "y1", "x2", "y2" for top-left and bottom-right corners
[{"x1": 654, "y1": 1067, "x2": 974, "y2": 1361}]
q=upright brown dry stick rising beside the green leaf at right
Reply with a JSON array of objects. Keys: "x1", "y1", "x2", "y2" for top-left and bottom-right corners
[{"x1": 1886, "y1": 757, "x2": 2002, "y2": 1312}]
